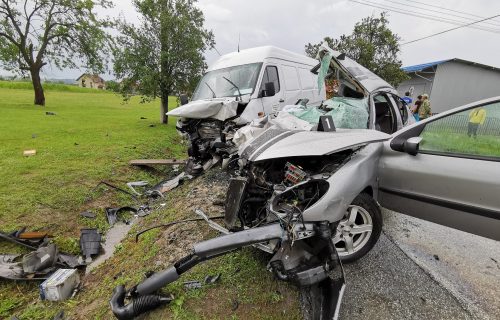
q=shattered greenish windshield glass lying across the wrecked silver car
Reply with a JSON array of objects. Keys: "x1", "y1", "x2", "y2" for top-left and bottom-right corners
[{"x1": 284, "y1": 97, "x2": 369, "y2": 129}]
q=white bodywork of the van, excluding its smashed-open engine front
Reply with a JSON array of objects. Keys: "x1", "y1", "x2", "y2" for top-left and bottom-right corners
[{"x1": 168, "y1": 46, "x2": 325, "y2": 124}]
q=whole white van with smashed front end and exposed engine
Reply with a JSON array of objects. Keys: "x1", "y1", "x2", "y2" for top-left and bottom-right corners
[{"x1": 167, "y1": 46, "x2": 325, "y2": 174}]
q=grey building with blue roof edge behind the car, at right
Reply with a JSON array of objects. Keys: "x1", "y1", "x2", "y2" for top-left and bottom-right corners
[{"x1": 397, "y1": 58, "x2": 500, "y2": 113}]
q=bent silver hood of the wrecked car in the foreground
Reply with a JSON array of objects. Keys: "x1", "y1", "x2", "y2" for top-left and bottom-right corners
[{"x1": 240, "y1": 128, "x2": 391, "y2": 161}]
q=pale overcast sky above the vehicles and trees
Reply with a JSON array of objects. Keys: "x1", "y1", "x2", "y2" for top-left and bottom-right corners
[{"x1": 9, "y1": 0, "x2": 500, "y2": 78}]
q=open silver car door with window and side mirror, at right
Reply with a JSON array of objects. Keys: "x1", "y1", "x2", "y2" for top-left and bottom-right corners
[{"x1": 378, "y1": 97, "x2": 500, "y2": 240}]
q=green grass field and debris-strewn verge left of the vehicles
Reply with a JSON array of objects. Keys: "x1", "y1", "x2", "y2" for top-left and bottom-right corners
[{"x1": 0, "y1": 82, "x2": 300, "y2": 320}]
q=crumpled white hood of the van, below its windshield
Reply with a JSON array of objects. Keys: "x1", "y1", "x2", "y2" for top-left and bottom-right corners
[{"x1": 167, "y1": 98, "x2": 238, "y2": 121}]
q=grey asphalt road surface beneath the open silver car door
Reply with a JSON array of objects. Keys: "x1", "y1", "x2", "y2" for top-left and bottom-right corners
[{"x1": 340, "y1": 211, "x2": 500, "y2": 320}]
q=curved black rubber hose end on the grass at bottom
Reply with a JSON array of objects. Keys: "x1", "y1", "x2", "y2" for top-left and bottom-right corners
[{"x1": 109, "y1": 285, "x2": 171, "y2": 320}]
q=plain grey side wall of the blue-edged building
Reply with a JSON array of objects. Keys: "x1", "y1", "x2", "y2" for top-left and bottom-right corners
[{"x1": 430, "y1": 61, "x2": 500, "y2": 112}]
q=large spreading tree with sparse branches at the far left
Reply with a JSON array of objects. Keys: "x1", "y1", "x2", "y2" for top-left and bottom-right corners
[{"x1": 0, "y1": 0, "x2": 111, "y2": 105}]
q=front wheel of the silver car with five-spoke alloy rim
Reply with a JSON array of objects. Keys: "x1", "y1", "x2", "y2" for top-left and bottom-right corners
[{"x1": 333, "y1": 193, "x2": 383, "y2": 263}]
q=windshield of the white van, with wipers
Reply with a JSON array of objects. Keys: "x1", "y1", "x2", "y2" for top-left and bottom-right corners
[{"x1": 192, "y1": 62, "x2": 262, "y2": 101}]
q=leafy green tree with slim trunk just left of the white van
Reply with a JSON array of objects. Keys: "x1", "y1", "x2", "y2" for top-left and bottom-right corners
[{"x1": 114, "y1": 0, "x2": 215, "y2": 123}]
